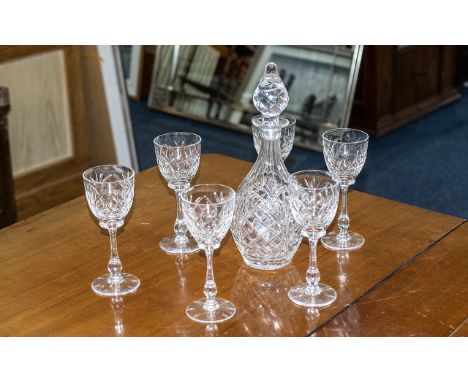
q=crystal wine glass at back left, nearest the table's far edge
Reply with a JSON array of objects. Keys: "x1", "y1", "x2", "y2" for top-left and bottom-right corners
[{"x1": 153, "y1": 133, "x2": 201, "y2": 255}]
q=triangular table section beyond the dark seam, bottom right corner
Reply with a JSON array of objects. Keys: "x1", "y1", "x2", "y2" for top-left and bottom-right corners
[{"x1": 316, "y1": 223, "x2": 468, "y2": 336}]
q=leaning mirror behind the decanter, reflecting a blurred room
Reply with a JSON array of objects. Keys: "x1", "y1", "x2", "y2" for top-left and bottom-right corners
[{"x1": 141, "y1": 45, "x2": 360, "y2": 150}]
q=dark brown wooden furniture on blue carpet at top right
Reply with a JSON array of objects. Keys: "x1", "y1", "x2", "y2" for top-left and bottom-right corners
[{"x1": 349, "y1": 46, "x2": 459, "y2": 136}]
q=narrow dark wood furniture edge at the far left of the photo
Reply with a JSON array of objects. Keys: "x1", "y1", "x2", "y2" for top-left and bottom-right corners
[{"x1": 0, "y1": 86, "x2": 16, "y2": 228}]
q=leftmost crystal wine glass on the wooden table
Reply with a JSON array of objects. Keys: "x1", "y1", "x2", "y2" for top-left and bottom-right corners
[{"x1": 83, "y1": 165, "x2": 140, "y2": 296}]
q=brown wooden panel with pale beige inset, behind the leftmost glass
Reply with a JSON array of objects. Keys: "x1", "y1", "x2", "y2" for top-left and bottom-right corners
[{"x1": 0, "y1": 45, "x2": 116, "y2": 220}]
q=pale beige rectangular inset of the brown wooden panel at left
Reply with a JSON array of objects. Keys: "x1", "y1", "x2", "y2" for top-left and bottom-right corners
[{"x1": 0, "y1": 50, "x2": 73, "y2": 176}]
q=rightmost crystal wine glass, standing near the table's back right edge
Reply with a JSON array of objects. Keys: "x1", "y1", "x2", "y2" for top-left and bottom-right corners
[{"x1": 322, "y1": 129, "x2": 369, "y2": 251}]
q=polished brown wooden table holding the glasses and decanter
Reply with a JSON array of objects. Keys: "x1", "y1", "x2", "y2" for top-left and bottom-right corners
[{"x1": 0, "y1": 154, "x2": 468, "y2": 336}]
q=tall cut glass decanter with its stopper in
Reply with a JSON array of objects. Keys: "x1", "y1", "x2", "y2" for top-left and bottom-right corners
[{"x1": 231, "y1": 63, "x2": 301, "y2": 270}]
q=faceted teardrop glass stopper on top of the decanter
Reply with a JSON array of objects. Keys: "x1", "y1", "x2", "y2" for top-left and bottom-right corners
[{"x1": 253, "y1": 62, "x2": 289, "y2": 118}]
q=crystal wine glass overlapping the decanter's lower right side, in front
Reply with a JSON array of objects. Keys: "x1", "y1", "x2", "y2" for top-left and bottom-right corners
[{"x1": 288, "y1": 170, "x2": 339, "y2": 308}]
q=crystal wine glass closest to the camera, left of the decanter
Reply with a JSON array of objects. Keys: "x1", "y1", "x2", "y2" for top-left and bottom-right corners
[{"x1": 182, "y1": 184, "x2": 236, "y2": 323}]
